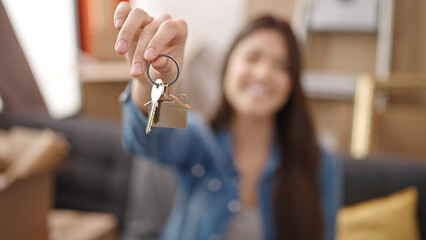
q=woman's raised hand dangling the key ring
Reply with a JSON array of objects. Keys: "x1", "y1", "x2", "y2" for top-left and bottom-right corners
[{"x1": 114, "y1": 2, "x2": 188, "y2": 114}]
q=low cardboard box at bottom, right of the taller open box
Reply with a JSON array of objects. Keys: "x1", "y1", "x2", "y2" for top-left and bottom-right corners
[{"x1": 49, "y1": 209, "x2": 117, "y2": 240}]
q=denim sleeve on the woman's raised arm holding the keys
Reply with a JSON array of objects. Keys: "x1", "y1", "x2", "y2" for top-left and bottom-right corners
[{"x1": 120, "y1": 82, "x2": 212, "y2": 169}]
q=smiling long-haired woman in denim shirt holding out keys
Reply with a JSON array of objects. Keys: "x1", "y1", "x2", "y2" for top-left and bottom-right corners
[{"x1": 114, "y1": 3, "x2": 340, "y2": 240}]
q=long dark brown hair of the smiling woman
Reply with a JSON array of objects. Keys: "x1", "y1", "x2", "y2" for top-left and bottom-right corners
[{"x1": 212, "y1": 16, "x2": 323, "y2": 240}]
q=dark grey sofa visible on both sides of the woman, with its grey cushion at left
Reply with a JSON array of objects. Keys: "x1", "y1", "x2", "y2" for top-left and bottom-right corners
[{"x1": 0, "y1": 112, "x2": 426, "y2": 240}]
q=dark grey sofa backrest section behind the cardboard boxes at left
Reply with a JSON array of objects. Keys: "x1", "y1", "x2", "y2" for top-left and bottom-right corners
[{"x1": 0, "y1": 112, "x2": 131, "y2": 230}]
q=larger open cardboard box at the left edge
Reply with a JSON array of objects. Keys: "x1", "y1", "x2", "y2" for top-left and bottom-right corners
[{"x1": 0, "y1": 127, "x2": 69, "y2": 240}]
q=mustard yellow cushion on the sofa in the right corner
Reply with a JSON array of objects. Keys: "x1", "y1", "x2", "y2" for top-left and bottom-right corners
[{"x1": 336, "y1": 187, "x2": 420, "y2": 240}]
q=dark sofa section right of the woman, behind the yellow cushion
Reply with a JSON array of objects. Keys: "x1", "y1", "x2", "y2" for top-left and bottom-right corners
[{"x1": 342, "y1": 156, "x2": 426, "y2": 237}]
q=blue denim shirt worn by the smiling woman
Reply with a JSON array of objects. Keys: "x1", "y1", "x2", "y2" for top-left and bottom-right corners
[{"x1": 120, "y1": 81, "x2": 341, "y2": 240}]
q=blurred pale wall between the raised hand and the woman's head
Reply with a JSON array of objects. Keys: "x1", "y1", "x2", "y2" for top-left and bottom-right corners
[{"x1": 131, "y1": 0, "x2": 246, "y2": 116}]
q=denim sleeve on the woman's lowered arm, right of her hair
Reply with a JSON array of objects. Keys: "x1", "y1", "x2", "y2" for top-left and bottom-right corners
[{"x1": 320, "y1": 152, "x2": 343, "y2": 240}]
